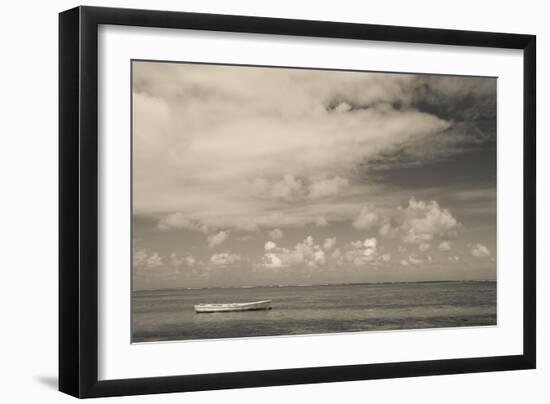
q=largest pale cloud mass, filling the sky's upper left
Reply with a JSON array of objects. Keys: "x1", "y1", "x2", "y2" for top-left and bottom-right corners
[{"x1": 133, "y1": 62, "x2": 452, "y2": 233}]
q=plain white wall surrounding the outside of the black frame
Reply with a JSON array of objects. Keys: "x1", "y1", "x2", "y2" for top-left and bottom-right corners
[{"x1": 0, "y1": 0, "x2": 550, "y2": 404}]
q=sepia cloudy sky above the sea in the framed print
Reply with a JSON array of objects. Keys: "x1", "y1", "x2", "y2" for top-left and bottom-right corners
[{"x1": 132, "y1": 61, "x2": 497, "y2": 290}]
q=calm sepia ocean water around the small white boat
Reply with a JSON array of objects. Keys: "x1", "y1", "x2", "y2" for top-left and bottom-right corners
[{"x1": 132, "y1": 281, "x2": 497, "y2": 342}]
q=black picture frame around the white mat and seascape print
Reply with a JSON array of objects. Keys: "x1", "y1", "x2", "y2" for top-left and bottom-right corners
[{"x1": 59, "y1": 7, "x2": 536, "y2": 398}]
